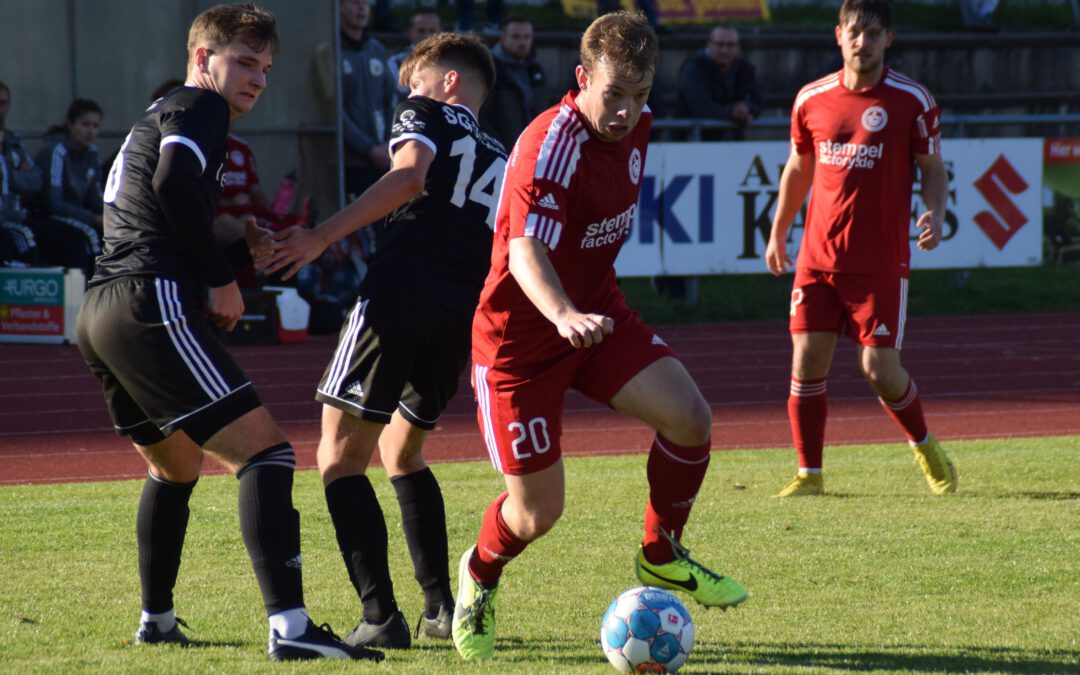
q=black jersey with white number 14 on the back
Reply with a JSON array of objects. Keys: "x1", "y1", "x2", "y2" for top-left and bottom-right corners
[{"x1": 360, "y1": 96, "x2": 507, "y2": 316}]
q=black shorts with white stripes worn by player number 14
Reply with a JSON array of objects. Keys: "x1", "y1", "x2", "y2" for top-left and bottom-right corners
[{"x1": 315, "y1": 297, "x2": 472, "y2": 430}]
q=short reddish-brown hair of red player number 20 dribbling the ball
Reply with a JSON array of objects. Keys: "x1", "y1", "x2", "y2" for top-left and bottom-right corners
[{"x1": 581, "y1": 11, "x2": 660, "y2": 83}]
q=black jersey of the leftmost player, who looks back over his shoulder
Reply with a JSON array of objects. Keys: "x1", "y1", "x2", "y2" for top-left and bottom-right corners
[{"x1": 91, "y1": 86, "x2": 232, "y2": 289}]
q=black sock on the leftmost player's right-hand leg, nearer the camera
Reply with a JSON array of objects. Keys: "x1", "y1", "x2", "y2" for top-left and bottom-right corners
[{"x1": 237, "y1": 443, "x2": 303, "y2": 616}]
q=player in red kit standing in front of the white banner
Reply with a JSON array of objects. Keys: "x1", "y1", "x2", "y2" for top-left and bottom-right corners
[{"x1": 766, "y1": 0, "x2": 957, "y2": 497}]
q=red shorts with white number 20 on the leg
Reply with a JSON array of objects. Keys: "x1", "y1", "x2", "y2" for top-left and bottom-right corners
[{"x1": 472, "y1": 311, "x2": 675, "y2": 475}]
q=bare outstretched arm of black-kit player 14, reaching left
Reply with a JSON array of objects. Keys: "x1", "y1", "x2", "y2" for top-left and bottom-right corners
[{"x1": 253, "y1": 140, "x2": 435, "y2": 279}]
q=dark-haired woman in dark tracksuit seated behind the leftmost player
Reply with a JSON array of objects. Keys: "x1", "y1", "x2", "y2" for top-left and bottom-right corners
[{"x1": 30, "y1": 98, "x2": 104, "y2": 280}]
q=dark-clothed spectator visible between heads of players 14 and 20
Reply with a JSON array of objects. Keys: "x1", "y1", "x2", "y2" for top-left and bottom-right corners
[{"x1": 480, "y1": 16, "x2": 546, "y2": 150}]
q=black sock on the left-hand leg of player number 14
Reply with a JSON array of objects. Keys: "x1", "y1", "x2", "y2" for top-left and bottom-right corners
[{"x1": 326, "y1": 474, "x2": 397, "y2": 623}]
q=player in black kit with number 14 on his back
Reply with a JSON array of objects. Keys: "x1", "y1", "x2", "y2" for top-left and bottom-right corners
[{"x1": 256, "y1": 32, "x2": 507, "y2": 648}]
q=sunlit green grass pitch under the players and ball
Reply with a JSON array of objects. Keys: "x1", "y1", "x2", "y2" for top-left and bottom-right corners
[{"x1": 0, "y1": 436, "x2": 1080, "y2": 673}]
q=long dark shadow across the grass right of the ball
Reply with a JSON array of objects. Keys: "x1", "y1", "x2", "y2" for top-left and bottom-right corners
[{"x1": 687, "y1": 643, "x2": 1080, "y2": 673}]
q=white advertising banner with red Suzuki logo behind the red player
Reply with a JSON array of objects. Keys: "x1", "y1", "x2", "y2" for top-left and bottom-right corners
[{"x1": 616, "y1": 138, "x2": 1043, "y2": 276}]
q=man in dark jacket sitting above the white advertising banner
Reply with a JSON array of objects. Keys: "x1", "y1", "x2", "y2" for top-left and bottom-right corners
[{"x1": 678, "y1": 26, "x2": 761, "y2": 140}]
